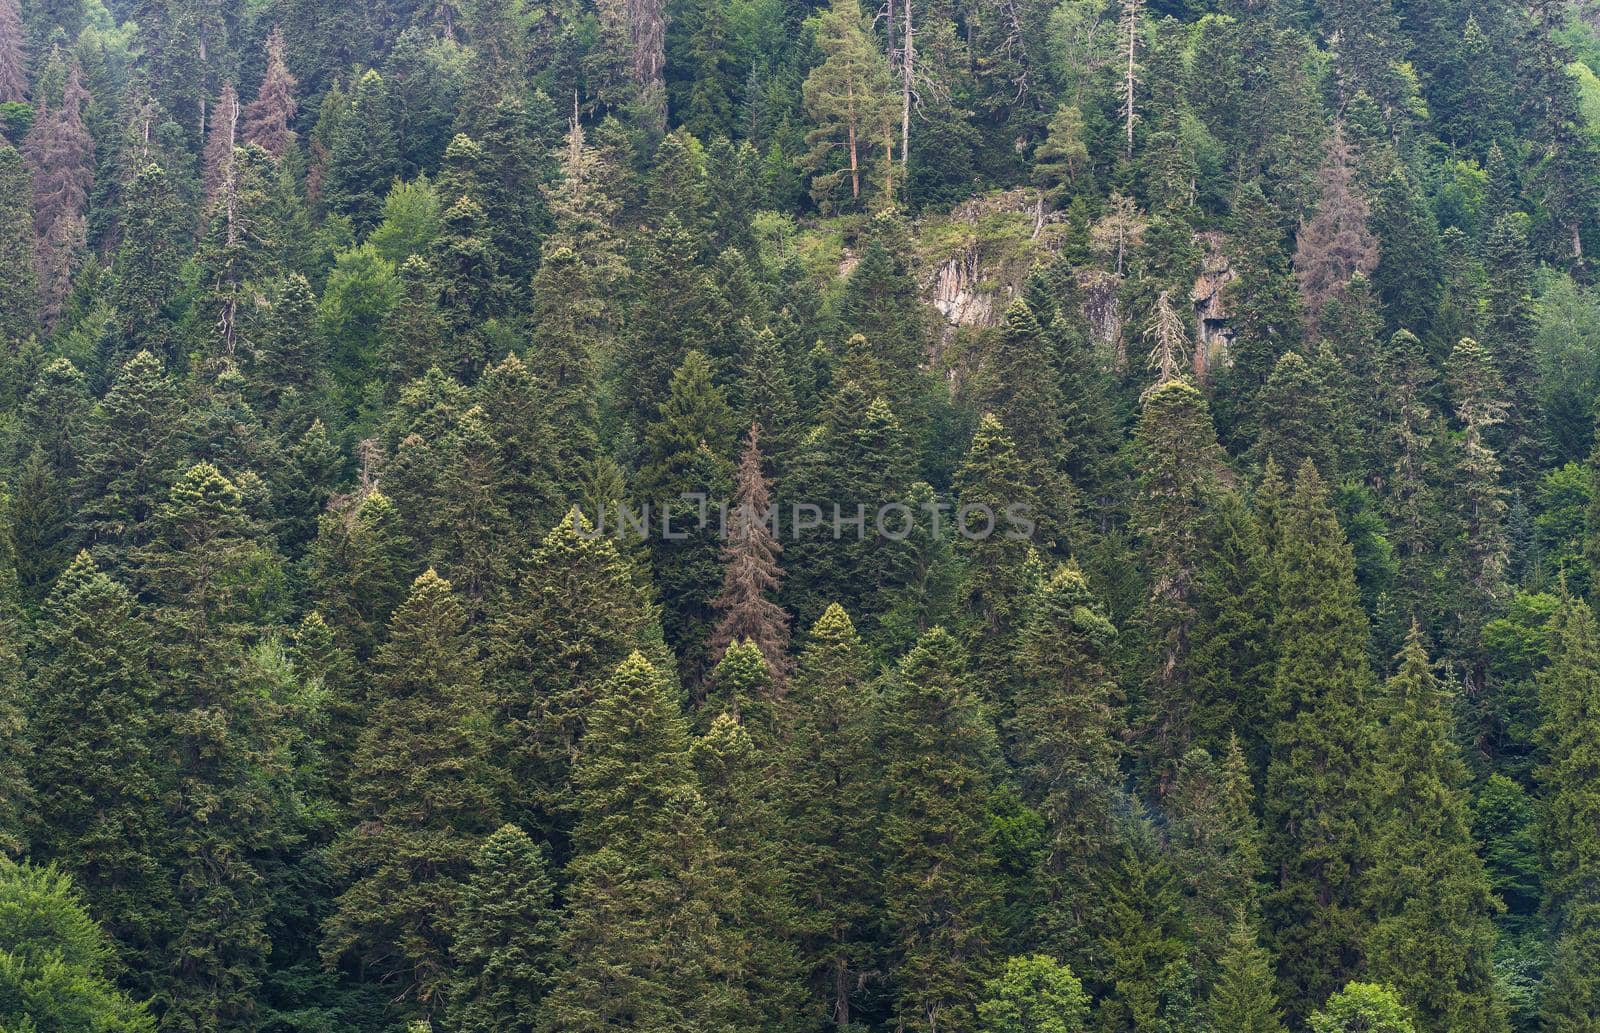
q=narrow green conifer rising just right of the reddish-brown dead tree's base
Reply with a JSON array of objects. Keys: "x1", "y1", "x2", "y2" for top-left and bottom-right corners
[{"x1": 782, "y1": 604, "x2": 880, "y2": 1030}]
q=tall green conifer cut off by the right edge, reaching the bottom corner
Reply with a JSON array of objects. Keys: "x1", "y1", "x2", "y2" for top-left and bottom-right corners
[{"x1": 1538, "y1": 598, "x2": 1600, "y2": 1033}]
